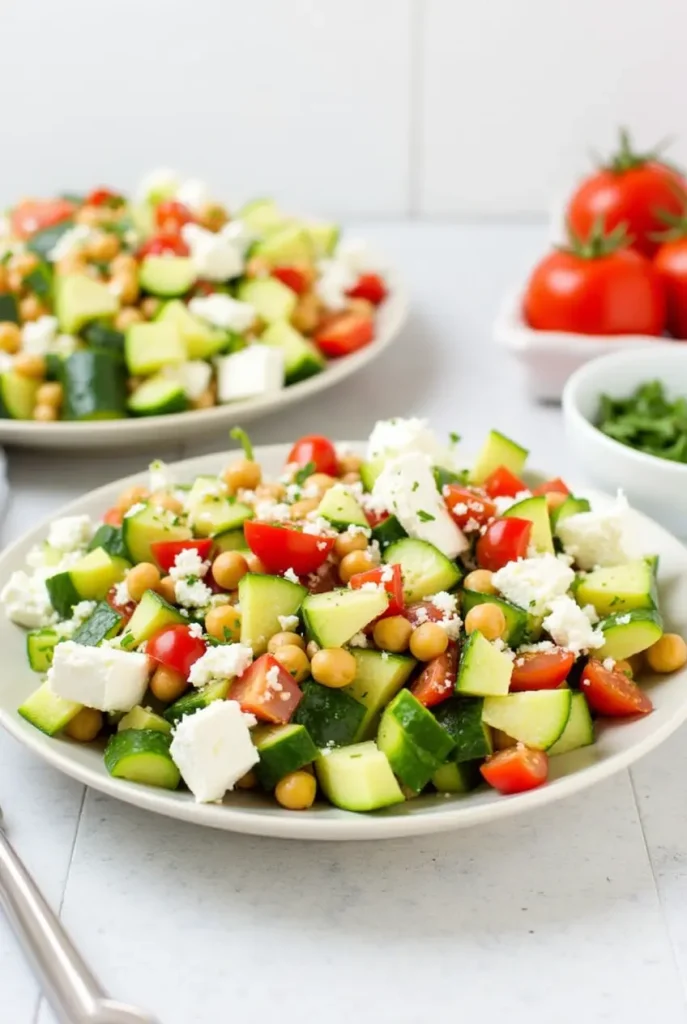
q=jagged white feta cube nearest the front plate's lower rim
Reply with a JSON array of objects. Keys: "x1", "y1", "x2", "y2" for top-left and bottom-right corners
[{"x1": 169, "y1": 700, "x2": 259, "y2": 803}]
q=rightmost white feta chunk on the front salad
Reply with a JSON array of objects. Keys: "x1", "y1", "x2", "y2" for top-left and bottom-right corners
[{"x1": 557, "y1": 492, "x2": 637, "y2": 569}]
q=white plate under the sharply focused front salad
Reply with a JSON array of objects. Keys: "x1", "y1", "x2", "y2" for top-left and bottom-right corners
[{"x1": 0, "y1": 444, "x2": 687, "y2": 840}]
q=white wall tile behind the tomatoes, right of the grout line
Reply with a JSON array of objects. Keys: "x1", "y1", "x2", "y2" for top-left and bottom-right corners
[{"x1": 418, "y1": 0, "x2": 687, "y2": 216}]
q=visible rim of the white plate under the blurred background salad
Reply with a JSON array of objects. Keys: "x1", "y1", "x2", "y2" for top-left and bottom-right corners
[{"x1": 0, "y1": 271, "x2": 409, "y2": 451}]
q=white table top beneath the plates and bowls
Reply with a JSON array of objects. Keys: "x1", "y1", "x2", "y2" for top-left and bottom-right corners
[{"x1": 0, "y1": 224, "x2": 687, "y2": 1024}]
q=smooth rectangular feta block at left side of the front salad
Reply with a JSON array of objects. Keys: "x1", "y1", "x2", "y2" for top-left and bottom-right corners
[{"x1": 47, "y1": 640, "x2": 148, "y2": 711}]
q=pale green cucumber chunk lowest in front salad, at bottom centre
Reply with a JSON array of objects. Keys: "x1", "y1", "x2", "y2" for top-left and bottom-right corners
[{"x1": 315, "y1": 740, "x2": 404, "y2": 811}]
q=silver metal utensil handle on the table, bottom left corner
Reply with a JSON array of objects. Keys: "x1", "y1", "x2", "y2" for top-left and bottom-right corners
[{"x1": 0, "y1": 827, "x2": 156, "y2": 1024}]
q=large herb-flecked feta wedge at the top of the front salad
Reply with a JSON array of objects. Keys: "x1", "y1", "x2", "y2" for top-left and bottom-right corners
[{"x1": 372, "y1": 452, "x2": 468, "y2": 558}]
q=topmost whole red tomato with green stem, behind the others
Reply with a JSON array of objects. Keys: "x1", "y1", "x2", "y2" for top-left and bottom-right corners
[{"x1": 567, "y1": 130, "x2": 686, "y2": 256}]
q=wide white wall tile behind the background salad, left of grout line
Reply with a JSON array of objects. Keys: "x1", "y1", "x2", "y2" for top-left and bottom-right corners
[{"x1": 0, "y1": 0, "x2": 411, "y2": 215}]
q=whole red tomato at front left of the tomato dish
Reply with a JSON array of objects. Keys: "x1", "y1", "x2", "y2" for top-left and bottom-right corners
[{"x1": 524, "y1": 225, "x2": 665, "y2": 335}]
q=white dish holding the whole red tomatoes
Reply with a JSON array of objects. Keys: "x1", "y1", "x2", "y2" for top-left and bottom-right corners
[{"x1": 493, "y1": 287, "x2": 682, "y2": 401}]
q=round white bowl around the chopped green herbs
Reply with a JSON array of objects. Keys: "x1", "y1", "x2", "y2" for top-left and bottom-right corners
[{"x1": 563, "y1": 343, "x2": 687, "y2": 538}]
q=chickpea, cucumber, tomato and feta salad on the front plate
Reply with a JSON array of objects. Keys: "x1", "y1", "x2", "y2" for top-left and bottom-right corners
[{"x1": 1, "y1": 419, "x2": 687, "y2": 812}]
